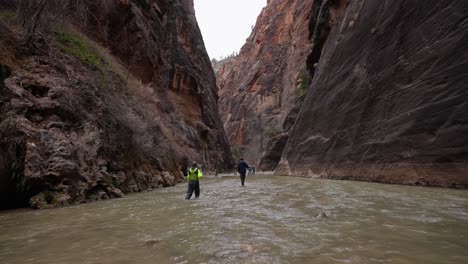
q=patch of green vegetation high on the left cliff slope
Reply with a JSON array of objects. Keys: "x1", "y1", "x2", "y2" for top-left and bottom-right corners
[{"x1": 57, "y1": 33, "x2": 105, "y2": 69}]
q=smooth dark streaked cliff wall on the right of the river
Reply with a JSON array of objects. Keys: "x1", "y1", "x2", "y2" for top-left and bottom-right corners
[{"x1": 277, "y1": 0, "x2": 468, "y2": 188}]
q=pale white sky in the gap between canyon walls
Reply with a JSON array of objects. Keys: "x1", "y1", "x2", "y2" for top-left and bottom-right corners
[{"x1": 194, "y1": 0, "x2": 266, "y2": 59}]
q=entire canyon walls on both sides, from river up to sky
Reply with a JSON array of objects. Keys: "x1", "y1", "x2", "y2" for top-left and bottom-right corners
[{"x1": 0, "y1": 0, "x2": 468, "y2": 209}]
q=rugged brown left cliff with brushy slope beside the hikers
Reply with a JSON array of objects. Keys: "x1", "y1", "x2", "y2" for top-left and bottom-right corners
[{"x1": 0, "y1": 0, "x2": 232, "y2": 208}]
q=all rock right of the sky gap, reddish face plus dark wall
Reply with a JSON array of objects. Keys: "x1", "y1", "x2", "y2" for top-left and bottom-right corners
[{"x1": 216, "y1": 0, "x2": 468, "y2": 188}]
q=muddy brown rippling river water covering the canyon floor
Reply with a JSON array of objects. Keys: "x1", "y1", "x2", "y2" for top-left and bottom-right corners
[{"x1": 0, "y1": 176, "x2": 468, "y2": 264}]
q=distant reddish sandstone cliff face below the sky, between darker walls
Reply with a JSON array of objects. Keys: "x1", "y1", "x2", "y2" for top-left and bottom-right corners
[{"x1": 215, "y1": 0, "x2": 313, "y2": 166}]
